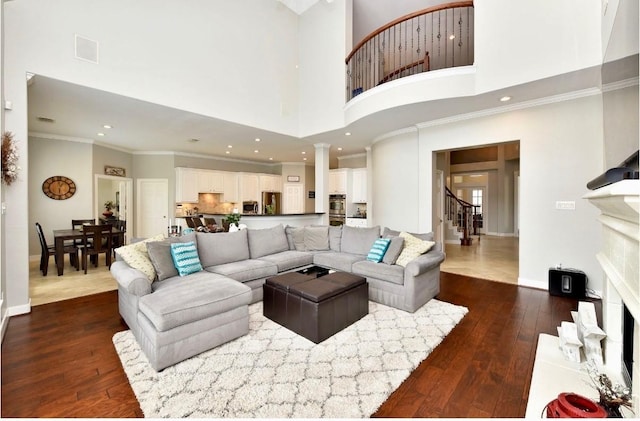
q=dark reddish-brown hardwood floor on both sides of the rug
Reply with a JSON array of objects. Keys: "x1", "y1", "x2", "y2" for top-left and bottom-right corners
[{"x1": 1, "y1": 273, "x2": 577, "y2": 418}]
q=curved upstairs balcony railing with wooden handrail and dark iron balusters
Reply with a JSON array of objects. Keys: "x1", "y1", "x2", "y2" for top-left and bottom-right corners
[{"x1": 346, "y1": 1, "x2": 473, "y2": 101}]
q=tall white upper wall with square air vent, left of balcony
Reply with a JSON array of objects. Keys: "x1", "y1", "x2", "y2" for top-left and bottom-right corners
[{"x1": 3, "y1": 0, "x2": 302, "y2": 135}]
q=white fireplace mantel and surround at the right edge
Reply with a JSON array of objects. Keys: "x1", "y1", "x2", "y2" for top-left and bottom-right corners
[{"x1": 584, "y1": 180, "x2": 640, "y2": 415}]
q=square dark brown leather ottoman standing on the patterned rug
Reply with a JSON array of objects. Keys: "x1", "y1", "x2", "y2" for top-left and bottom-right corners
[{"x1": 263, "y1": 272, "x2": 369, "y2": 343}]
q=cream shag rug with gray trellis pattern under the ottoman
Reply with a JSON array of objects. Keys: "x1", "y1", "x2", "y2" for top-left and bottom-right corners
[{"x1": 113, "y1": 299, "x2": 468, "y2": 418}]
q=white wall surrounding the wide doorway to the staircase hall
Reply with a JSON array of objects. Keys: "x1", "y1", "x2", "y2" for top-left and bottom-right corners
[{"x1": 373, "y1": 95, "x2": 603, "y2": 290}]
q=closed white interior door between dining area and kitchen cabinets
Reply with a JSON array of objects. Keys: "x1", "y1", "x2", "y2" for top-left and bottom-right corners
[{"x1": 135, "y1": 178, "x2": 169, "y2": 238}]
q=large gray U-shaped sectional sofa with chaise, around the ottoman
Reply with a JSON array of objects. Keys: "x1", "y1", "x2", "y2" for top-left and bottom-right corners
[{"x1": 111, "y1": 225, "x2": 445, "y2": 370}]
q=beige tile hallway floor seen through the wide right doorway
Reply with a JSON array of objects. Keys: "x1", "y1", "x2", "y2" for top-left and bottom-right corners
[{"x1": 440, "y1": 235, "x2": 519, "y2": 285}]
